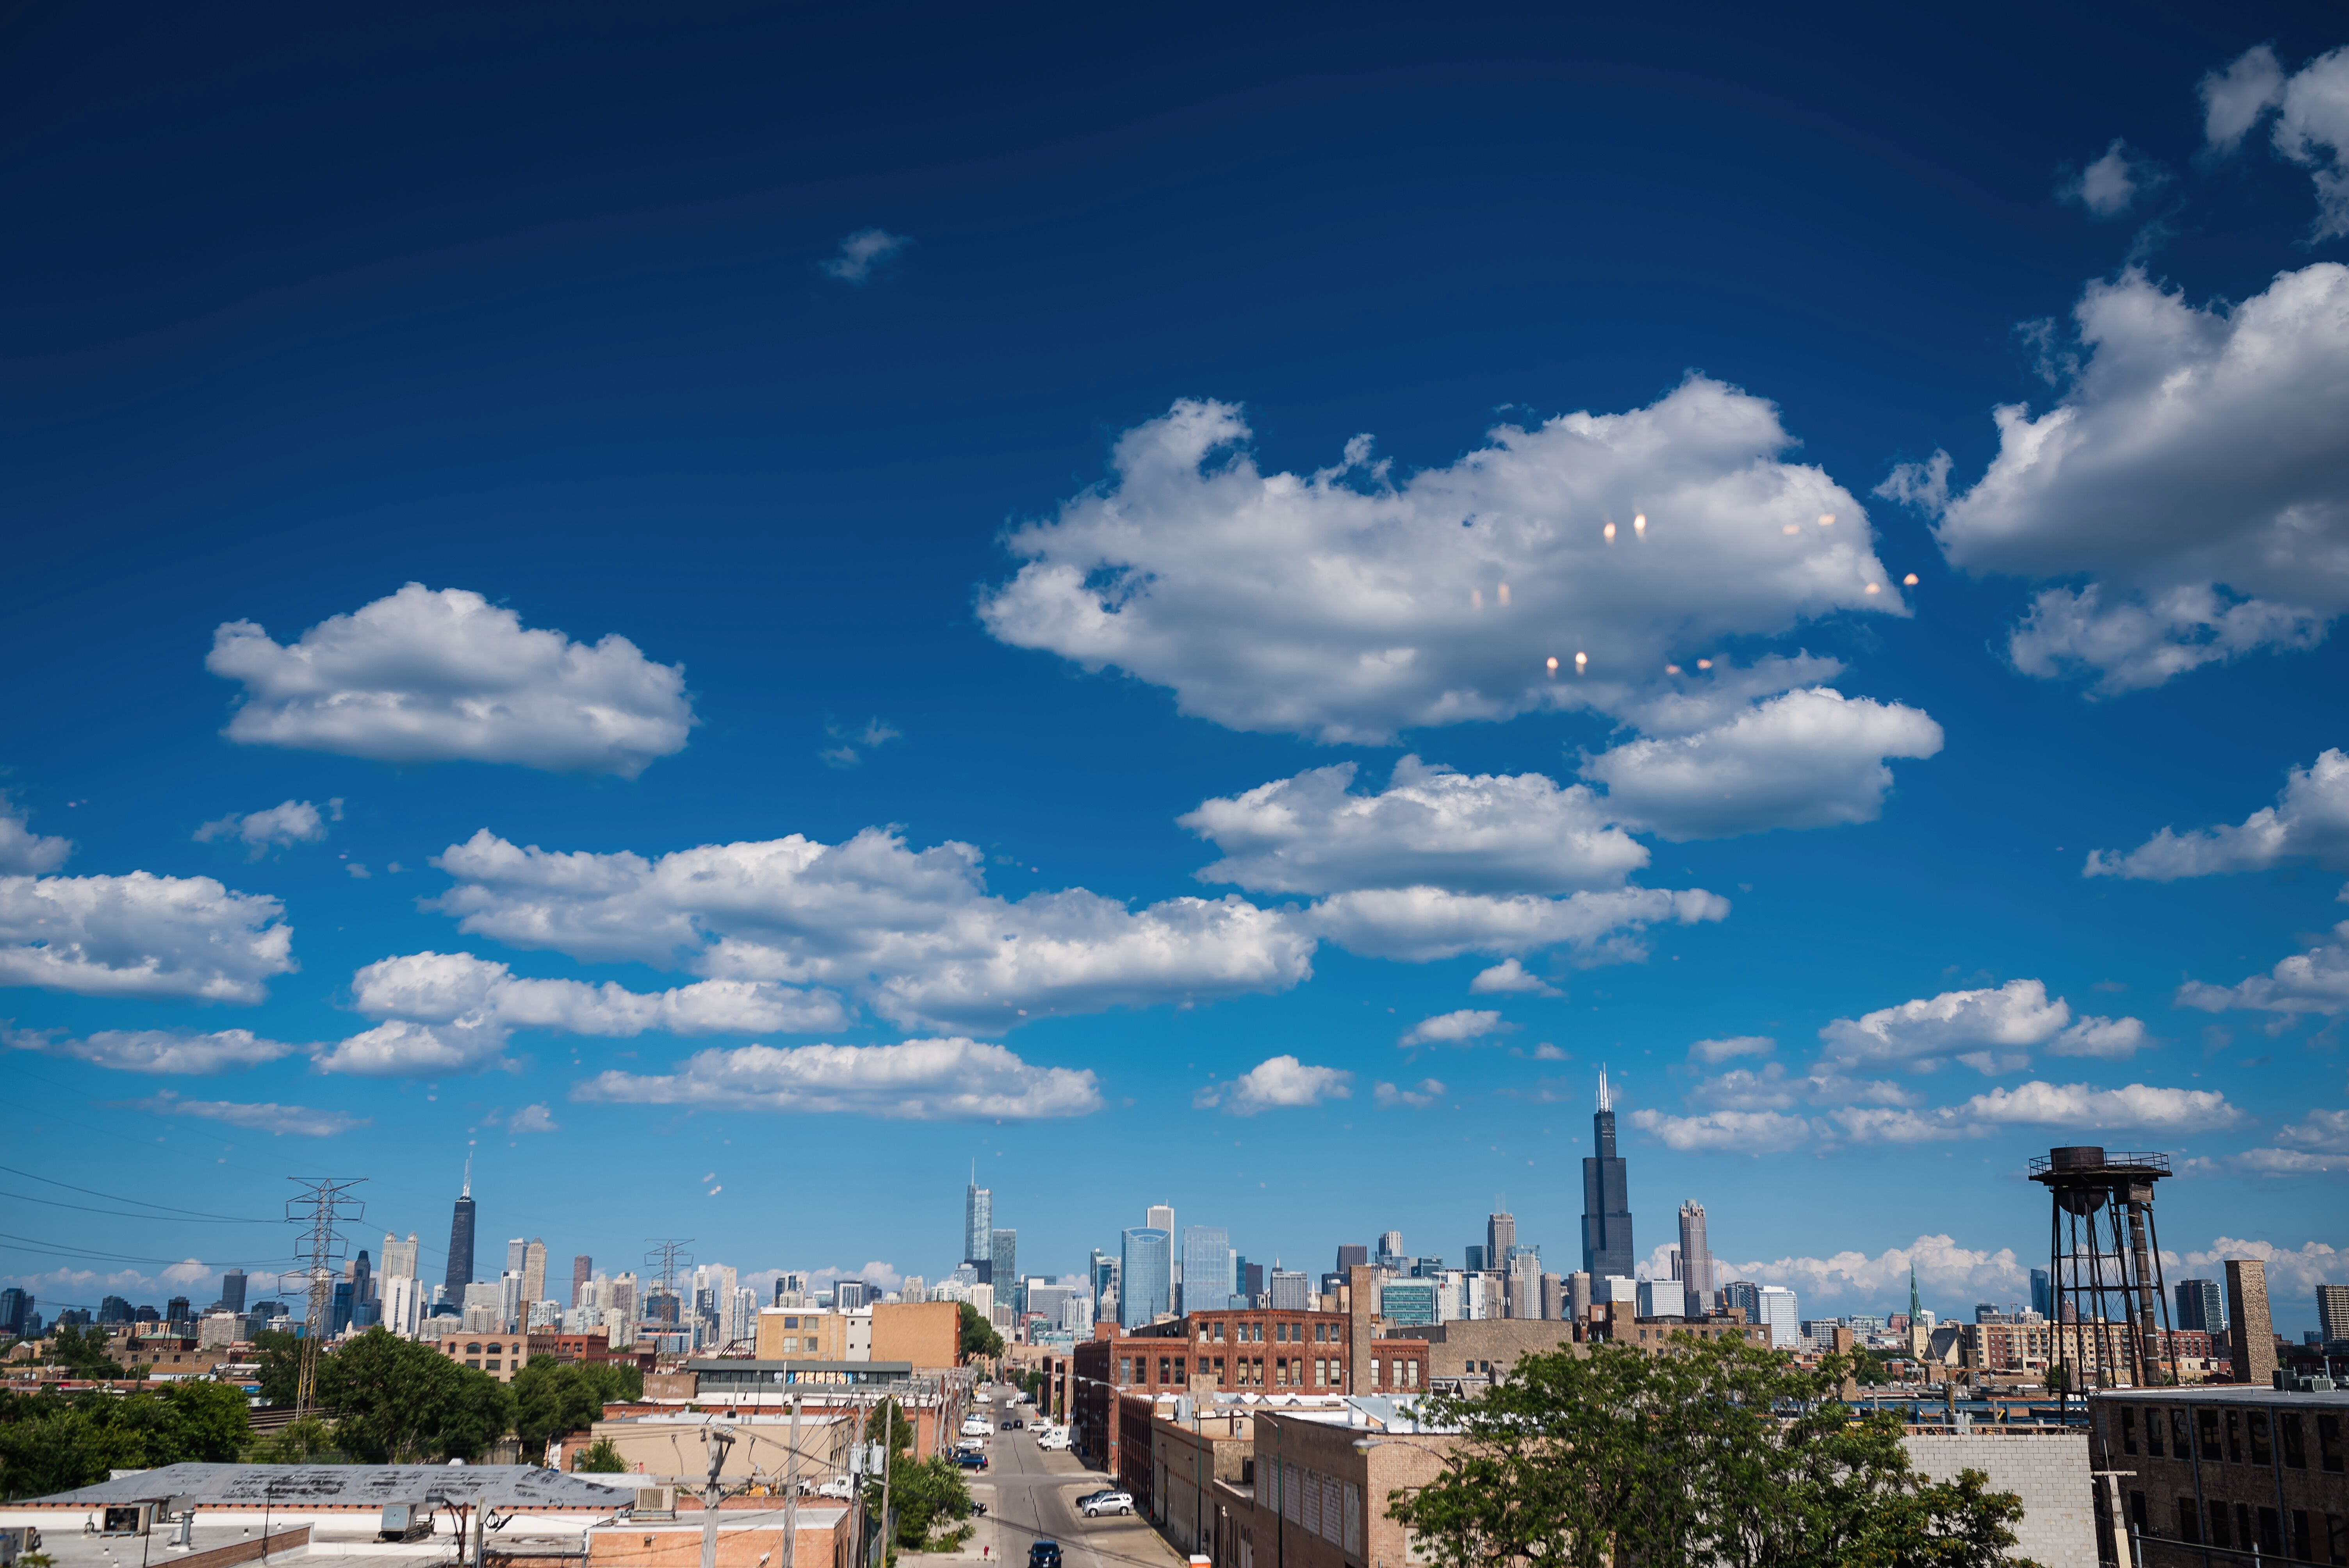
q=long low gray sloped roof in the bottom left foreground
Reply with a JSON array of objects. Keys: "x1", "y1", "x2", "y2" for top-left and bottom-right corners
[{"x1": 19, "y1": 1462, "x2": 636, "y2": 1512}]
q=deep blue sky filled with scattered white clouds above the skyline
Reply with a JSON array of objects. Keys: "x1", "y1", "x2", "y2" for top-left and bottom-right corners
[{"x1": 0, "y1": 7, "x2": 2349, "y2": 1329}]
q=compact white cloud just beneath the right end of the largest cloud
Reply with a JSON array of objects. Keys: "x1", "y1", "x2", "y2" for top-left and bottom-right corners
[{"x1": 1583, "y1": 688, "x2": 1940, "y2": 840}]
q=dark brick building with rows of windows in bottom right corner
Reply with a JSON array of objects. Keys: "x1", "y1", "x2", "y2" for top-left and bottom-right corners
[{"x1": 2088, "y1": 1385, "x2": 2349, "y2": 1568}]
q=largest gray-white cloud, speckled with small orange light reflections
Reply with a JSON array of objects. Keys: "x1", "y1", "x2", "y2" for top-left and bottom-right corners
[{"x1": 980, "y1": 376, "x2": 1907, "y2": 744}]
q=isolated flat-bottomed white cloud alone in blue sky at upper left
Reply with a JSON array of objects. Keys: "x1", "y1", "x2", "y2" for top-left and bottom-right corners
[{"x1": 204, "y1": 582, "x2": 695, "y2": 779}]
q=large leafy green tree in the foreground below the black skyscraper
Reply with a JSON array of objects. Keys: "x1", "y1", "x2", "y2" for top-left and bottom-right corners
[{"x1": 1388, "y1": 1338, "x2": 2023, "y2": 1568}]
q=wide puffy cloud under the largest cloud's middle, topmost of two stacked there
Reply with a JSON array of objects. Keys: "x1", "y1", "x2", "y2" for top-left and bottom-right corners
[{"x1": 1177, "y1": 756, "x2": 1647, "y2": 892}]
